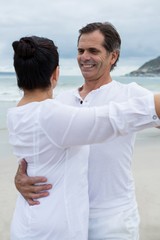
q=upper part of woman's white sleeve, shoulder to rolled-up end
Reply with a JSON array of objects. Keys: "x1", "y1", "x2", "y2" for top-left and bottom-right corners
[{"x1": 39, "y1": 99, "x2": 116, "y2": 147}]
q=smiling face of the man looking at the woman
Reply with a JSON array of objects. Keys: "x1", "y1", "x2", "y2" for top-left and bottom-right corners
[{"x1": 77, "y1": 31, "x2": 113, "y2": 81}]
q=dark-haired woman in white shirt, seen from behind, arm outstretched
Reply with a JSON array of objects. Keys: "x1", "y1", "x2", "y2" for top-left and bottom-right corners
[{"x1": 8, "y1": 36, "x2": 160, "y2": 240}]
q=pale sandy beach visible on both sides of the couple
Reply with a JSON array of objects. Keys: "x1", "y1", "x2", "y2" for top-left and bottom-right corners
[{"x1": 0, "y1": 129, "x2": 160, "y2": 240}]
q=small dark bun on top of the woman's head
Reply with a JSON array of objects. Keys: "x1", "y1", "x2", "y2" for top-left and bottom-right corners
[{"x1": 12, "y1": 37, "x2": 36, "y2": 59}]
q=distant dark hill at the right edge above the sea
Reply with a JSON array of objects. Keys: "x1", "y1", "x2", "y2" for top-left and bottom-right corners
[{"x1": 127, "y1": 56, "x2": 160, "y2": 77}]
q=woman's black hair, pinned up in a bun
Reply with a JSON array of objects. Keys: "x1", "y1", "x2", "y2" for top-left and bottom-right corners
[{"x1": 12, "y1": 36, "x2": 59, "y2": 90}]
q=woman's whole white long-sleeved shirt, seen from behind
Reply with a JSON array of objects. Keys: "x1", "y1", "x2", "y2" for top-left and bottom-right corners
[{"x1": 7, "y1": 94, "x2": 158, "y2": 240}]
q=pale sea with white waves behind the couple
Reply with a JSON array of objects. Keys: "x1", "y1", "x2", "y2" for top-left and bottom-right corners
[{"x1": 0, "y1": 73, "x2": 160, "y2": 130}]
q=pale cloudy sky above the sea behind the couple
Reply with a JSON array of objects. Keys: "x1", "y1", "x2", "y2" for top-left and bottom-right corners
[{"x1": 0, "y1": 0, "x2": 160, "y2": 75}]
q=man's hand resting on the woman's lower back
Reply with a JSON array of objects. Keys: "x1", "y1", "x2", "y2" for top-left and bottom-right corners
[{"x1": 15, "y1": 159, "x2": 52, "y2": 205}]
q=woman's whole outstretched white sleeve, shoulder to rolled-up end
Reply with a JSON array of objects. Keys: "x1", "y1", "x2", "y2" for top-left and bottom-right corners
[{"x1": 40, "y1": 94, "x2": 160, "y2": 147}]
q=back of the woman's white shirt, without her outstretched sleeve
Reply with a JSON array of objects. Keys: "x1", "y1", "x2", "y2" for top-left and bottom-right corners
[{"x1": 8, "y1": 100, "x2": 89, "y2": 240}]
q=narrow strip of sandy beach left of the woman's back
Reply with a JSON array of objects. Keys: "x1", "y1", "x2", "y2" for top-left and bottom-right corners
[{"x1": 0, "y1": 130, "x2": 17, "y2": 240}]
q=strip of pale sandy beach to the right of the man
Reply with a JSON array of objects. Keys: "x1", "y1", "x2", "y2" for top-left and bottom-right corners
[{"x1": 133, "y1": 129, "x2": 160, "y2": 240}]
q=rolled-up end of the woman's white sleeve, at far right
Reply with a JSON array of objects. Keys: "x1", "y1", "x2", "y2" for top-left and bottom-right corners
[{"x1": 109, "y1": 92, "x2": 160, "y2": 135}]
